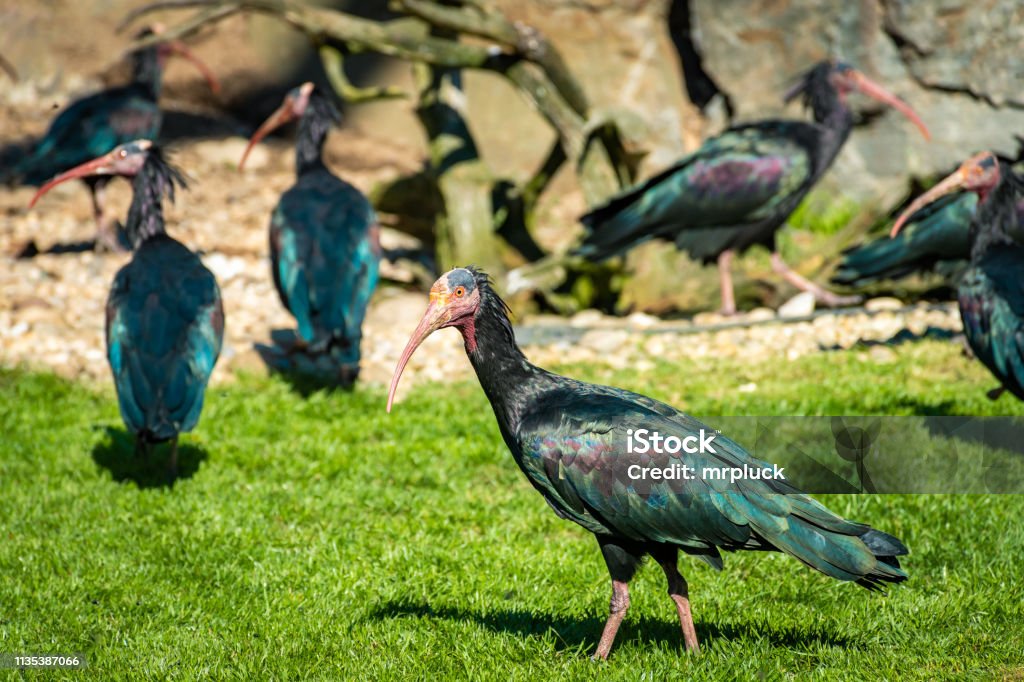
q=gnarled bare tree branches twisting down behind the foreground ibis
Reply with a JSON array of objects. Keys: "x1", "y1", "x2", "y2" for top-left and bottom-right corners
[{"x1": 121, "y1": 0, "x2": 636, "y2": 289}]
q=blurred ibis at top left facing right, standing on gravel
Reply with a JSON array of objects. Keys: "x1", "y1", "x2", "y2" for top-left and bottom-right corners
[{"x1": 10, "y1": 27, "x2": 220, "y2": 250}]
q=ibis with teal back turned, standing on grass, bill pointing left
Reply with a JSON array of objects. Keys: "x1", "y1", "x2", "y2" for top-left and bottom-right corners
[{"x1": 33, "y1": 139, "x2": 224, "y2": 476}]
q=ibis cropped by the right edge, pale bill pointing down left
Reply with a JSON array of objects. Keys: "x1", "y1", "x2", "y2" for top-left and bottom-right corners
[{"x1": 892, "y1": 152, "x2": 1024, "y2": 400}]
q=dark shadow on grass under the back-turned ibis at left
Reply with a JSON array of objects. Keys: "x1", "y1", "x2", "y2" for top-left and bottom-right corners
[{"x1": 92, "y1": 426, "x2": 209, "y2": 488}]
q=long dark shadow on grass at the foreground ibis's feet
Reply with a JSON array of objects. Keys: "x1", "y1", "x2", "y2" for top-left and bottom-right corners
[{"x1": 370, "y1": 601, "x2": 860, "y2": 655}]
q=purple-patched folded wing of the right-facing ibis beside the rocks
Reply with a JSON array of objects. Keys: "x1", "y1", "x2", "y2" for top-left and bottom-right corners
[{"x1": 579, "y1": 126, "x2": 812, "y2": 258}]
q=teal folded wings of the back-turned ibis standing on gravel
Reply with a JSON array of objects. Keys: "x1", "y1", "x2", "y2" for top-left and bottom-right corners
[{"x1": 271, "y1": 175, "x2": 380, "y2": 350}]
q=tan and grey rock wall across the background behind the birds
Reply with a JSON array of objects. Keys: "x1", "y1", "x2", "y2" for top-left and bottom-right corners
[{"x1": 0, "y1": 0, "x2": 1024, "y2": 310}]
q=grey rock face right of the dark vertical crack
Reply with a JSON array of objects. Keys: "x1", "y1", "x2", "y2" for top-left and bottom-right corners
[{"x1": 689, "y1": 0, "x2": 1024, "y2": 207}]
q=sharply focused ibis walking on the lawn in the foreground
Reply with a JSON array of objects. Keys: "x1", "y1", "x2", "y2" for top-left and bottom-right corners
[{"x1": 387, "y1": 267, "x2": 906, "y2": 658}]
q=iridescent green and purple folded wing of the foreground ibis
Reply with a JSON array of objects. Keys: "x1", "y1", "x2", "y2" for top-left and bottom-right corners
[{"x1": 519, "y1": 385, "x2": 897, "y2": 580}]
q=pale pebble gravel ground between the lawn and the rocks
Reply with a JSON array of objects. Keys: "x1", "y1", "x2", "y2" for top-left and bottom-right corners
[{"x1": 0, "y1": 103, "x2": 961, "y2": 395}]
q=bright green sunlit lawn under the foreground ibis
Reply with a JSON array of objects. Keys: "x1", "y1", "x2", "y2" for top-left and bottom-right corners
[{"x1": 0, "y1": 341, "x2": 1024, "y2": 680}]
